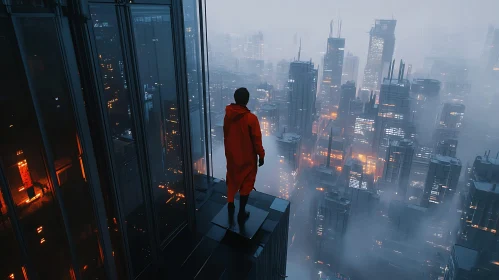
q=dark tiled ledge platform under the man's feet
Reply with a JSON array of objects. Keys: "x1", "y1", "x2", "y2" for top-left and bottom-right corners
[{"x1": 161, "y1": 177, "x2": 290, "y2": 280}]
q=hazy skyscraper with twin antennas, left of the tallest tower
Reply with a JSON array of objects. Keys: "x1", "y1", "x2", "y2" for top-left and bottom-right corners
[{"x1": 321, "y1": 21, "x2": 345, "y2": 113}]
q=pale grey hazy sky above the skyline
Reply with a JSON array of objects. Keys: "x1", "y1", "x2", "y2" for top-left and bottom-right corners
[{"x1": 206, "y1": 0, "x2": 499, "y2": 69}]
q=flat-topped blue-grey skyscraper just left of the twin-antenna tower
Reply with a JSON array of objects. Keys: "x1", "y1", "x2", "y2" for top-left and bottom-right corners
[{"x1": 287, "y1": 61, "x2": 317, "y2": 139}]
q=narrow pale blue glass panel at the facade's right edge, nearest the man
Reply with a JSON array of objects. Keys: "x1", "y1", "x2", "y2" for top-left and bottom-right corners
[{"x1": 183, "y1": 0, "x2": 207, "y2": 175}]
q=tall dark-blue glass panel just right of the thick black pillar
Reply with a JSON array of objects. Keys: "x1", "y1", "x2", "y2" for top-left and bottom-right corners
[{"x1": 90, "y1": 5, "x2": 151, "y2": 276}]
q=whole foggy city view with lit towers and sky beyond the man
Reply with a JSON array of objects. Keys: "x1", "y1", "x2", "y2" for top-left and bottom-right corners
[{"x1": 207, "y1": 0, "x2": 499, "y2": 280}]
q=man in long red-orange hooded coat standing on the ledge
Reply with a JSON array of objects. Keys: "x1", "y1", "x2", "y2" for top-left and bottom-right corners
[{"x1": 224, "y1": 88, "x2": 265, "y2": 221}]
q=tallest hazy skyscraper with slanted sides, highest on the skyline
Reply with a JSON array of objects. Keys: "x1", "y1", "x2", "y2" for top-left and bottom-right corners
[{"x1": 362, "y1": 19, "x2": 397, "y2": 90}]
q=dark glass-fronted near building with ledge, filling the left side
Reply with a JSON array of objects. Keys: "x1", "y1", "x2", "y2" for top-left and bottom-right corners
[{"x1": 0, "y1": 0, "x2": 290, "y2": 280}]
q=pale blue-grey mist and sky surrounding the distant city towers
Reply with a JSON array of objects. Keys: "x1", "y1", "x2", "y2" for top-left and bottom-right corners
[{"x1": 207, "y1": 0, "x2": 499, "y2": 280}]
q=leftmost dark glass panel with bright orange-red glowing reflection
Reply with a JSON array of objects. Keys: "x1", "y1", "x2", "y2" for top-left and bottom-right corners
[{"x1": 0, "y1": 18, "x2": 71, "y2": 279}]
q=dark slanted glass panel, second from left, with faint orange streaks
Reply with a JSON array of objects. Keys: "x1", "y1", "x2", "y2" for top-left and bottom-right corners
[{"x1": 17, "y1": 18, "x2": 105, "y2": 278}]
